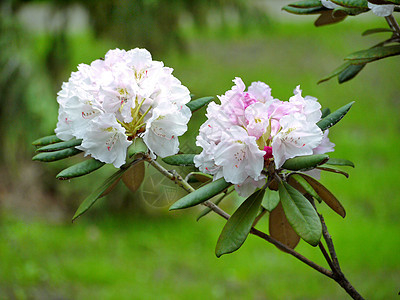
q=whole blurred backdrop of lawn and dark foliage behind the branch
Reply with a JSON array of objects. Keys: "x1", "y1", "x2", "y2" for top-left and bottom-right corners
[{"x1": 0, "y1": 0, "x2": 400, "y2": 299}]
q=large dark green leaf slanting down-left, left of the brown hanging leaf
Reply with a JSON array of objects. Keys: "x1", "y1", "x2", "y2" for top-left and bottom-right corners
[{"x1": 215, "y1": 190, "x2": 265, "y2": 257}]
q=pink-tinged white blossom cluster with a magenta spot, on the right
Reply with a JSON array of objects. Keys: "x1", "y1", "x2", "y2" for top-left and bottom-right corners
[{"x1": 194, "y1": 77, "x2": 334, "y2": 196}]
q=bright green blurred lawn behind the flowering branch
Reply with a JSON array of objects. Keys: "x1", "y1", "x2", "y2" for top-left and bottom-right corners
[{"x1": 0, "y1": 14, "x2": 400, "y2": 299}]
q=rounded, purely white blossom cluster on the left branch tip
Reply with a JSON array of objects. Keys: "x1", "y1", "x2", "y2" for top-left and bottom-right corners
[{"x1": 55, "y1": 48, "x2": 191, "y2": 167}]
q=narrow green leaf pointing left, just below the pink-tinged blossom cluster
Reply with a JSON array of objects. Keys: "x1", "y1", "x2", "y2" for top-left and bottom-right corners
[{"x1": 169, "y1": 178, "x2": 231, "y2": 210}]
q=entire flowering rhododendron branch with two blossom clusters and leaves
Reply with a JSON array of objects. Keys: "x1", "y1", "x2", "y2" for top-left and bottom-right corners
[{"x1": 33, "y1": 45, "x2": 368, "y2": 299}]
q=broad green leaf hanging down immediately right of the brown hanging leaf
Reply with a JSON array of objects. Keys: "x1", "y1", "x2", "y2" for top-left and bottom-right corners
[{"x1": 279, "y1": 182, "x2": 322, "y2": 246}]
